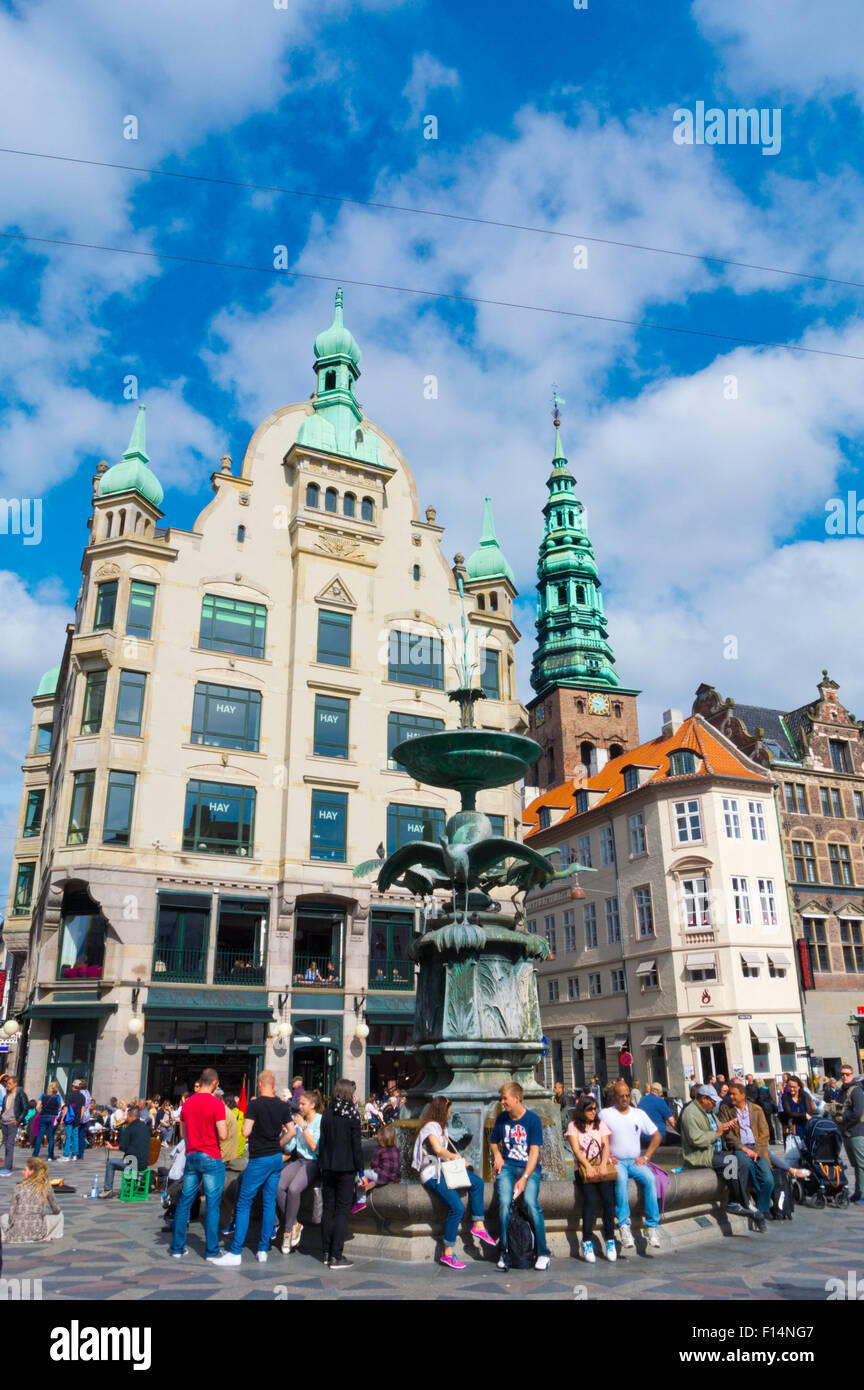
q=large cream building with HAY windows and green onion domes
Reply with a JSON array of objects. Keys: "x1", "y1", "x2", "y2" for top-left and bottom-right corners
[{"x1": 6, "y1": 292, "x2": 526, "y2": 1097}]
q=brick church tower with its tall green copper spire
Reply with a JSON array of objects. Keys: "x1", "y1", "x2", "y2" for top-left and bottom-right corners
[{"x1": 528, "y1": 395, "x2": 639, "y2": 794}]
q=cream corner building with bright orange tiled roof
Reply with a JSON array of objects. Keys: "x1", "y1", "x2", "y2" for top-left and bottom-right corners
[{"x1": 525, "y1": 710, "x2": 806, "y2": 1095}]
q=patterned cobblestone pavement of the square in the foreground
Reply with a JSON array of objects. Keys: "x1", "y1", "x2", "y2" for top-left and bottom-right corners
[{"x1": 0, "y1": 1152, "x2": 864, "y2": 1301}]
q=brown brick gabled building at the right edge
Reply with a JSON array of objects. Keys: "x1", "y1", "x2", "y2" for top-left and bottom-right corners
[{"x1": 693, "y1": 671, "x2": 864, "y2": 1076}]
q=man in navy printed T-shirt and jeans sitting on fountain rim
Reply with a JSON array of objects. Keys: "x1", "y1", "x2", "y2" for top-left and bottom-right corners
[{"x1": 489, "y1": 1081, "x2": 551, "y2": 1269}]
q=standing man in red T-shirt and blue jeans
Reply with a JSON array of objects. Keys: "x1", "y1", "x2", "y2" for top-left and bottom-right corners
[{"x1": 171, "y1": 1066, "x2": 228, "y2": 1261}]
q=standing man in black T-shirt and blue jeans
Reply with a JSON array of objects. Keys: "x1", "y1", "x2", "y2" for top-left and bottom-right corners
[{"x1": 211, "y1": 1072, "x2": 293, "y2": 1265}]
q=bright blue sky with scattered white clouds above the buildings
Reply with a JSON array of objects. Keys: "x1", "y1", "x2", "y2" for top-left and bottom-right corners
[{"x1": 0, "y1": 0, "x2": 864, "y2": 889}]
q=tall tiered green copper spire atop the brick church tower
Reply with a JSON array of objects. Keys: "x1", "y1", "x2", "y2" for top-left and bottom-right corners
[{"x1": 531, "y1": 405, "x2": 621, "y2": 695}]
